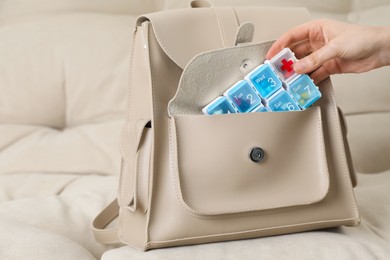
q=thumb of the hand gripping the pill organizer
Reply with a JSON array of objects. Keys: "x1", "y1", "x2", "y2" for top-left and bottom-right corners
[{"x1": 294, "y1": 43, "x2": 338, "y2": 74}]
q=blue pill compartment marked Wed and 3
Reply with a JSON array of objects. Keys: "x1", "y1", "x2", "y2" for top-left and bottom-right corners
[{"x1": 245, "y1": 64, "x2": 282, "y2": 99}]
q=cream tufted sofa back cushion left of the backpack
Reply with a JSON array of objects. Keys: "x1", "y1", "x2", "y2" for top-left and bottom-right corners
[{"x1": 0, "y1": 9, "x2": 135, "y2": 174}]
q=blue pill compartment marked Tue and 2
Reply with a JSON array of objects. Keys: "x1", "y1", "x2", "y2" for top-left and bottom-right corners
[{"x1": 224, "y1": 80, "x2": 261, "y2": 113}]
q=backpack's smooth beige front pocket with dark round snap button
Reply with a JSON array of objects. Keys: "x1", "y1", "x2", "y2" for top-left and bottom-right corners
[{"x1": 170, "y1": 107, "x2": 329, "y2": 217}]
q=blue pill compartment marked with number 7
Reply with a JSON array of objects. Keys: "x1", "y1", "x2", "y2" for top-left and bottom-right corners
[{"x1": 287, "y1": 74, "x2": 321, "y2": 109}]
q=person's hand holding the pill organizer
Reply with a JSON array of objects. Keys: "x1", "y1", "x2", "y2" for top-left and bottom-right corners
[{"x1": 267, "y1": 20, "x2": 390, "y2": 83}]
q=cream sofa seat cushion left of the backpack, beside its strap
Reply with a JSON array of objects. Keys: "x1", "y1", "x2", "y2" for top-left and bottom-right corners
[{"x1": 0, "y1": 173, "x2": 117, "y2": 259}]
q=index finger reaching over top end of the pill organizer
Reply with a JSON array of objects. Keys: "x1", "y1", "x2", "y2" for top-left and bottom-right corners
[{"x1": 266, "y1": 22, "x2": 321, "y2": 59}]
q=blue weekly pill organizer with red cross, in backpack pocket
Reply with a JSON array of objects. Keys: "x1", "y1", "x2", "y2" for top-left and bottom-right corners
[{"x1": 202, "y1": 48, "x2": 321, "y2": 115}]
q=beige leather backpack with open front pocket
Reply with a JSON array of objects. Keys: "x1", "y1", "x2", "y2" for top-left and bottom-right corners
[{"x1": 94, "y1": 2, "x2": 359, "y2": 250}]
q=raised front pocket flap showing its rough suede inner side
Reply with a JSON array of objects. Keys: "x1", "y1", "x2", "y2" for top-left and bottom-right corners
[{"x1": 168, "y1": 42, "x2": 272, "y2": 115}]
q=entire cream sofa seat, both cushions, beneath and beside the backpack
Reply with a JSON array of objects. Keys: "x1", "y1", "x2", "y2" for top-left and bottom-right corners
[{"x1": 0, "y1": 171, "x2": 390, "y2": 260}]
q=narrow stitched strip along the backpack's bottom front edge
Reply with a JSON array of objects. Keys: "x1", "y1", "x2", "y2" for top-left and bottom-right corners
[{"x1": 147, "y1": 218, "x2": 355, "y2": 248}]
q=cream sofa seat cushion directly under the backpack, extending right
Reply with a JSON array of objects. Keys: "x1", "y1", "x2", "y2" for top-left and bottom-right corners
[{"x1": 102, "y1": 171, "x2": 390, "y2": 260}]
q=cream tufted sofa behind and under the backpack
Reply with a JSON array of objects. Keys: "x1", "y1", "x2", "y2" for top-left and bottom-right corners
[{"x1": 0, "y1": 0, "x2": 390, "y2": 260}]
